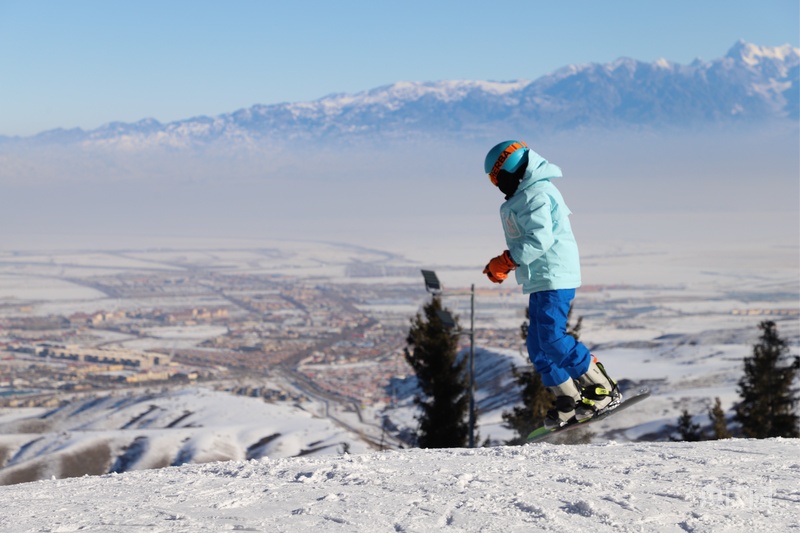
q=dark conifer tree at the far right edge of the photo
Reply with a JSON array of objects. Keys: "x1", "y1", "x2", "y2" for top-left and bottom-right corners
[{"x1": 734, "y1": 320, "x2": 800, "y2": 439}]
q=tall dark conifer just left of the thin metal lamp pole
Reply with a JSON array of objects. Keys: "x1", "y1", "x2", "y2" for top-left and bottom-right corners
[{"x1": 405, "y1": 296, "x2": 477, "y2": 448}]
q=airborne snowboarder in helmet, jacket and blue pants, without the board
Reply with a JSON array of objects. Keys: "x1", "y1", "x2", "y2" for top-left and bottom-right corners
[{"x1": 483, "y1": 141, "x2": 622, "y2": 428}]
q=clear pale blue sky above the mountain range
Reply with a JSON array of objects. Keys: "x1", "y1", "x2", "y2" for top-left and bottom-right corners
[{"x1": 0, "y1": 0, "x2": 800, "y2": 136}]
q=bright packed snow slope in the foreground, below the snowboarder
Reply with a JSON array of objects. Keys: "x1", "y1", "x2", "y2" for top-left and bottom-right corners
[{"x1": 0, "y1": 439, "x2": 800, "y2": 533}]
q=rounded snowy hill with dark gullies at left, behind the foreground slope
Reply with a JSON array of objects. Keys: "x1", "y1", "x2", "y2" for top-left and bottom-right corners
[{"x1": 0, "y1": 387, "x2": 371, "y2": 484}]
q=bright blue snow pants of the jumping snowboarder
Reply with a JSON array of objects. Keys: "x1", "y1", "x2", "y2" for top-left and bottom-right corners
[{"x1": 527, "y1": 289, "x2": 591, "y2": 387}]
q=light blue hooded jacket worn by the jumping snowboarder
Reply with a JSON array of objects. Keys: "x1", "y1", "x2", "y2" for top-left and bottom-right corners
[{"x1": 500, "y1": 150, "x2": 581, "y2": 294}]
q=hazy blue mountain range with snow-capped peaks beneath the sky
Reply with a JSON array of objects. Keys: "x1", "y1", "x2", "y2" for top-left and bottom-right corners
[{"x1": 0, "y1": 41, "x2": 800, "y2": 150}]
